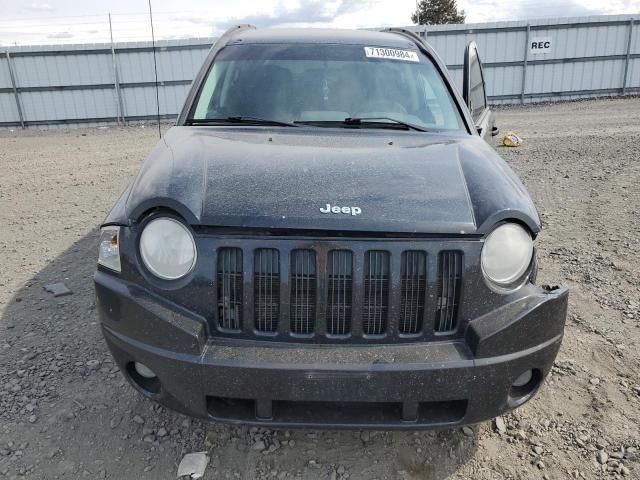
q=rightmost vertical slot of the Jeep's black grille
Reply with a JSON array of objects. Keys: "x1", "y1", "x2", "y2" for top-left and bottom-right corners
[{"x1": 435, "y1": 250, "x2": 462, "y2": 333}]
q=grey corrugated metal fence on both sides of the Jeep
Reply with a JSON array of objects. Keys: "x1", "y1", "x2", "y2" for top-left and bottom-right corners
[{"x1": 0, "y1": 15, "x2": 640, "y2": 127}]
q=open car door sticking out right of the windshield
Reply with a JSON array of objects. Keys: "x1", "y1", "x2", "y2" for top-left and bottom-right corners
[{"x1": 462, "y1": 41, "x2": 498, "y2": 139}]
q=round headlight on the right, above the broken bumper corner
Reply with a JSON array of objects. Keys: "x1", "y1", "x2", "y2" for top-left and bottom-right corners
[{"x1": 482, "y1": 223, "x2": 533, "y2": 287}]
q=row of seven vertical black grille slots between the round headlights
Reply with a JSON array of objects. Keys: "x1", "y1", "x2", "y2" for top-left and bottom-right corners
[{"x1": 214, "y1": 242, "x2": 463, "y2": 340}]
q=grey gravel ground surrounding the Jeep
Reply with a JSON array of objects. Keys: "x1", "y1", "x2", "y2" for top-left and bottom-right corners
[{"x1": 0, "y1": 99, "x2": 640, "y2": 480}]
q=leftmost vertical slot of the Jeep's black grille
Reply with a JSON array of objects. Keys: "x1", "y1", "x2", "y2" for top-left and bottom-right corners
[{"x1": 217, "y1": 248, "x2": 242, "y2": 330}]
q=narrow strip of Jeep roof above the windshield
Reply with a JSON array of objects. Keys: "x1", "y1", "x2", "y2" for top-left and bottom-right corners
[{"x1": 229, "y1": 28, "x2": 417, "y2": 49}]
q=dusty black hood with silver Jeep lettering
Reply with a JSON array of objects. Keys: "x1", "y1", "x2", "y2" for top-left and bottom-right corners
[{"x1": 116, "y1": 127, "x2": 540, "y2": 235}]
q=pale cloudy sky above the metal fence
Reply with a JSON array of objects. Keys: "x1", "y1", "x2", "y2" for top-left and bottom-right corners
[{"x1": 0, "y1": 0, "x2": 640, "y2": 45}]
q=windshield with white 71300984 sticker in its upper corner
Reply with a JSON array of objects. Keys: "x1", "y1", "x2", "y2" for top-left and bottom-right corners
[{"x1": 190, "y1": 44, "x2": 462, "y2": 130}]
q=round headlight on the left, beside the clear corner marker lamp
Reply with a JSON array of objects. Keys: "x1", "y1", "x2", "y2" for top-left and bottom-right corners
[{"x1": 140, "y1": 217, "x2": 197, "y2": 280}]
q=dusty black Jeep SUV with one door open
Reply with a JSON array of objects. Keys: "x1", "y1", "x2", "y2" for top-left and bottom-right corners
[{"x1": 95, "y1": 26, "x2": 568, "y2": 429}]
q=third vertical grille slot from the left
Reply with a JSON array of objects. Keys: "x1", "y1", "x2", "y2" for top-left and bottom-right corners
[{"x1": 290, "y1": 250, "x2": 317, "y2": 335}]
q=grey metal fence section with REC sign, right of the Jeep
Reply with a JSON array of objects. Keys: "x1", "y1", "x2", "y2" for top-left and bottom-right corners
[{"x1": 413, "y1": 15, "x2": 640, "y2": 104}]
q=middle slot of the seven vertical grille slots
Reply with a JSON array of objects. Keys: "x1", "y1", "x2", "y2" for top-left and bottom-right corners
[{"x1": 327, "y1": 250, "x2": 353, "y2": 335}]
